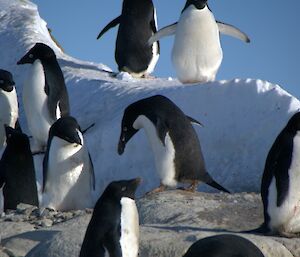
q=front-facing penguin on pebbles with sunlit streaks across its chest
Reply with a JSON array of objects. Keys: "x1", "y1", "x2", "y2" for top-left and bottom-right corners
[{"x1": 42, "y1": 116, "x2": 95, "y2": 211}]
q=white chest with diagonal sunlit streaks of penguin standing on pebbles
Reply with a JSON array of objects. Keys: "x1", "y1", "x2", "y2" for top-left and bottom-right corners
[{"x1": 43, "y1": 137, "x2": 92, "y2": 210}]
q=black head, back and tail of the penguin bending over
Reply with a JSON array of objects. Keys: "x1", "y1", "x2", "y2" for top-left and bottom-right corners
[{"x1": 118, "y1": 95, "x2": 228, "y2": 192}]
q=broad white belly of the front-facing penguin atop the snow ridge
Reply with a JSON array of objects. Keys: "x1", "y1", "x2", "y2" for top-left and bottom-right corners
[{"x1": 172, "y1": 5, "x2": 223, "y2": 83}]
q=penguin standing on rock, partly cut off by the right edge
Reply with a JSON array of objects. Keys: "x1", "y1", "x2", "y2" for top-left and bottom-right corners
[{"x1": 250, "y1": 112, "x2": 300, "y2": 237}]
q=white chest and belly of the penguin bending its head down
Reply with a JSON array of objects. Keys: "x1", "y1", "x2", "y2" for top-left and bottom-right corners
[{"x1": 133, "y1": 115, "x2": 177, "y2": 187}]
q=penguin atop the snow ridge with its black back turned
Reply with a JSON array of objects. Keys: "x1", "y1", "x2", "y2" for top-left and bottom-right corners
[{"x1": 97, "y1": 0, "x2": 160, "y2": 77}]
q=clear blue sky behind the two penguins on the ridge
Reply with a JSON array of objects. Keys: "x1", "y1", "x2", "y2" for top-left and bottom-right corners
[{"x1": 33, "y1": 0, "x2": 300, "y2": 99}]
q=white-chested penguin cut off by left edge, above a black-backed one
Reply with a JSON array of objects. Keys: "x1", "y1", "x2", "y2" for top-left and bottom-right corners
[{"x1": 0, "y1": 69, "x2": 19, "y2": 148}]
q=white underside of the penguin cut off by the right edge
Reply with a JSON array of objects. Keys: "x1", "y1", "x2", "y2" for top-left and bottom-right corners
[{"x1": 268, "y1": 132, "x2": 300, "y2": 233}]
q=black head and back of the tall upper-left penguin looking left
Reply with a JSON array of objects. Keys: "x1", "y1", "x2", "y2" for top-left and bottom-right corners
[{"x1": 17, "y1": 43, "x2": 70, "y2": 120}]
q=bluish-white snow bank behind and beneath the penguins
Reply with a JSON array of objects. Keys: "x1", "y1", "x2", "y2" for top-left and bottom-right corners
[{"x1": 0, "y1": 0, "x2": 300, "y2": 207}]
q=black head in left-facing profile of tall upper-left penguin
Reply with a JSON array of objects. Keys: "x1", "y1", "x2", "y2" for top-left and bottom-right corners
[{"x1": 17, "y1": 43, "x2": 56, "y2": 65}]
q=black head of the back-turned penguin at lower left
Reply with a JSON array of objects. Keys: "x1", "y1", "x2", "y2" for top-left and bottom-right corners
[{"x1": 4, "y1": 124, "x2": 30, "y2": 152}]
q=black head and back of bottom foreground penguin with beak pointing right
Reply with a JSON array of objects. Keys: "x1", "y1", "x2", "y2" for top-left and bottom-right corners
[{"x1": 79, "y1": 179, "x2": 140, "y2": 257}]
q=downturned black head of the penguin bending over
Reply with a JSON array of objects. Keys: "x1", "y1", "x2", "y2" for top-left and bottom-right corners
[{"x1": 118, "y1": 104, "x2": 139, "y2": 155}]
